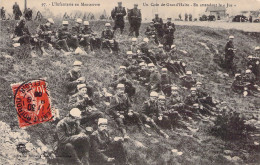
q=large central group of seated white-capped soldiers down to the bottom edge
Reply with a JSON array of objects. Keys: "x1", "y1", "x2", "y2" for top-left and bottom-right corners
[{"x1": 53, "y1": 31, "x2": 219, "y2": 165}]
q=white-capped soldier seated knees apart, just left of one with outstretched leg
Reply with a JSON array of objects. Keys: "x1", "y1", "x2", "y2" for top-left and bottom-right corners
[{"x1": 109, "y1": 84, "x2": 146, "y2": 139}]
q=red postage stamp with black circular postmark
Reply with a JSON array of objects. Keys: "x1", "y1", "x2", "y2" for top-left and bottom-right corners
[{"x1": 11, "y1": 80, "x2": 53, "y2": 127}]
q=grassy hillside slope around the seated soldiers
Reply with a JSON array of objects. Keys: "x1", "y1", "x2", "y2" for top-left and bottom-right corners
[{"x1": 0, "y1": 22, "x2": 260, "y2": 164}]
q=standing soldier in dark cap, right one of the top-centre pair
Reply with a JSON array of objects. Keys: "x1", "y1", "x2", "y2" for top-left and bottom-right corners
[{"x1": 128, "y1": 4, "x2": 142, "y2": 37}]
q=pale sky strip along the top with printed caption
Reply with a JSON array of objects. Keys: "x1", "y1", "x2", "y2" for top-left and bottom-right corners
[{"x1": 0, "y1": 0, "x2": 260, "y2": 19}]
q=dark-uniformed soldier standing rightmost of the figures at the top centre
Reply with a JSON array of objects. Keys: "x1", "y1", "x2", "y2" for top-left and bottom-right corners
[{"x1": 163, "y1": 18, "x2": 176, "y2": 49}]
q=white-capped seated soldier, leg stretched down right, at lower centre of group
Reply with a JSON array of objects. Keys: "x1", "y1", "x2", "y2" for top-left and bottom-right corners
[{"x1": 142, "y1": 92, "x2": 169, "y2": 138}]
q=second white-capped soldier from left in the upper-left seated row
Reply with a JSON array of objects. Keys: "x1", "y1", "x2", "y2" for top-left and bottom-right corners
[{"x1": 58, "y1": 21, "x2": 70, "y2": 52}]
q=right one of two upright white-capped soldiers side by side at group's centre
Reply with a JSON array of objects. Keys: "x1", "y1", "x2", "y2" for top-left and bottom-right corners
[{"x1": 161, "y1": 68, "x2": 171, "y2": 97}]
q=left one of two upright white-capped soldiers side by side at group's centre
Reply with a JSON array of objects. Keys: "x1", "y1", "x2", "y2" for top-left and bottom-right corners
[{"x1": 148, "y1": 63, "x2": 161, "y2": 92}]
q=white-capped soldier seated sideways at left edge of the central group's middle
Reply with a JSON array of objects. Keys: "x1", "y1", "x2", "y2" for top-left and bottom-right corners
[{"x1": 111, "y1": 66, "x2": 136, "y2": 98}]
